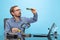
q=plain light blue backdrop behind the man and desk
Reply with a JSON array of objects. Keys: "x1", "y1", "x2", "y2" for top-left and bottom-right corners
[{"x1": 0, "y1": 0, "x2": 60, "y2": 40}]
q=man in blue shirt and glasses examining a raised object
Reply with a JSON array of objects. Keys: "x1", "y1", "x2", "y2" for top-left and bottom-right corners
[{"x1": 5, "y1": 6, "x2": 37, "y2": 40}]
